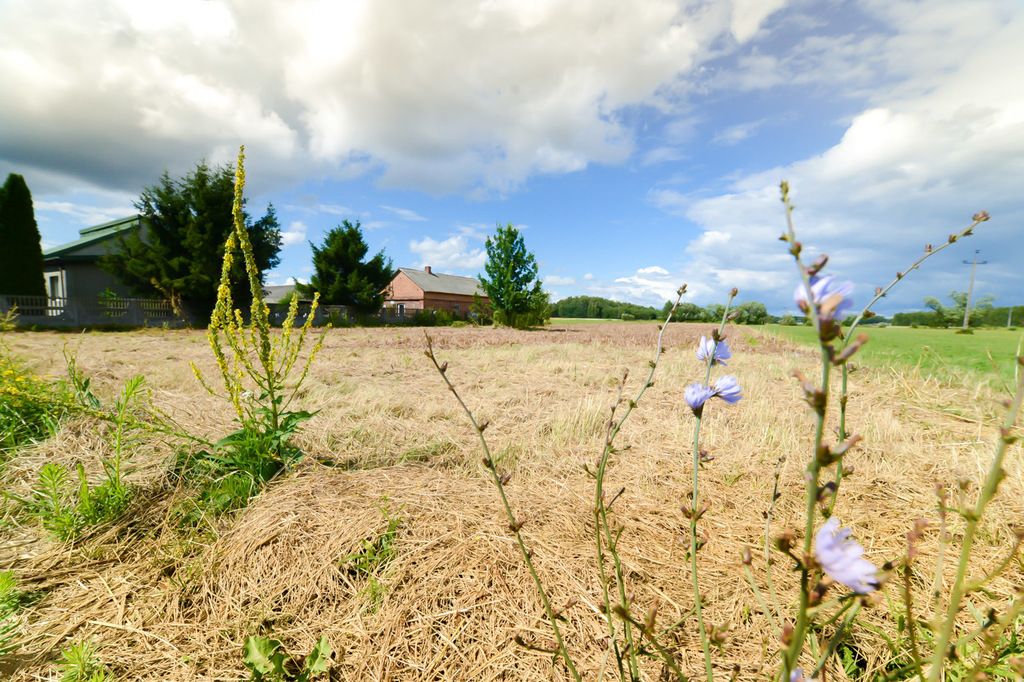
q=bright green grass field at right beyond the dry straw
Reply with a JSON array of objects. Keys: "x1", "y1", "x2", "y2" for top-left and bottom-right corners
[{"x1": 764, "y1": 325, "x2": 1024, "y2": 383}]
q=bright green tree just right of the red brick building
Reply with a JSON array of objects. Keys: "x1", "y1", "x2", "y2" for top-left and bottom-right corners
[{"x1": 478, "y1": 223, "x2": 550, "y2": 327}]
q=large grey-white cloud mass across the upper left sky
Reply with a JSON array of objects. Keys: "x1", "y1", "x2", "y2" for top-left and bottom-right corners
[{"x1": 0, "y1": 0, "x2": 783, "y2": 194}]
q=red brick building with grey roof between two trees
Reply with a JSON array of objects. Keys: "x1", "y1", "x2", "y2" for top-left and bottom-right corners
[{"x1": 384, "y1": 265, "x2": 488, "y2": 317}]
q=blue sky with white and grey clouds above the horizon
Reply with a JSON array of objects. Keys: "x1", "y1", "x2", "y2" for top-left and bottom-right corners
[{"x1": 0, "y1": 0, "x2": 1024, "y2": 313}]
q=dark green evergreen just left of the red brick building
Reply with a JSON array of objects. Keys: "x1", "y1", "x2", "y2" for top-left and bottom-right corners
[{"x1": 300, "y1": 220, "x2": 394, "y2": 313}]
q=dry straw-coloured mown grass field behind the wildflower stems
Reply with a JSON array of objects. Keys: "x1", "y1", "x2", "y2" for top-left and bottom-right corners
[{"x1": 0, "y1": 323, "x2": 1024, "y2": 681}]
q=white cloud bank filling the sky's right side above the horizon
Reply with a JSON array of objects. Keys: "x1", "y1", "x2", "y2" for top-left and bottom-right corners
[{"x1": 663, "y1": 3, "x2": 1024, "y2": 309}]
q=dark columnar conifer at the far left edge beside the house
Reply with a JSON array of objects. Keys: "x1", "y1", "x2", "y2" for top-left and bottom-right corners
[{"x1": 0, "y1": 173, "x2": 46, "y2": 296}]
